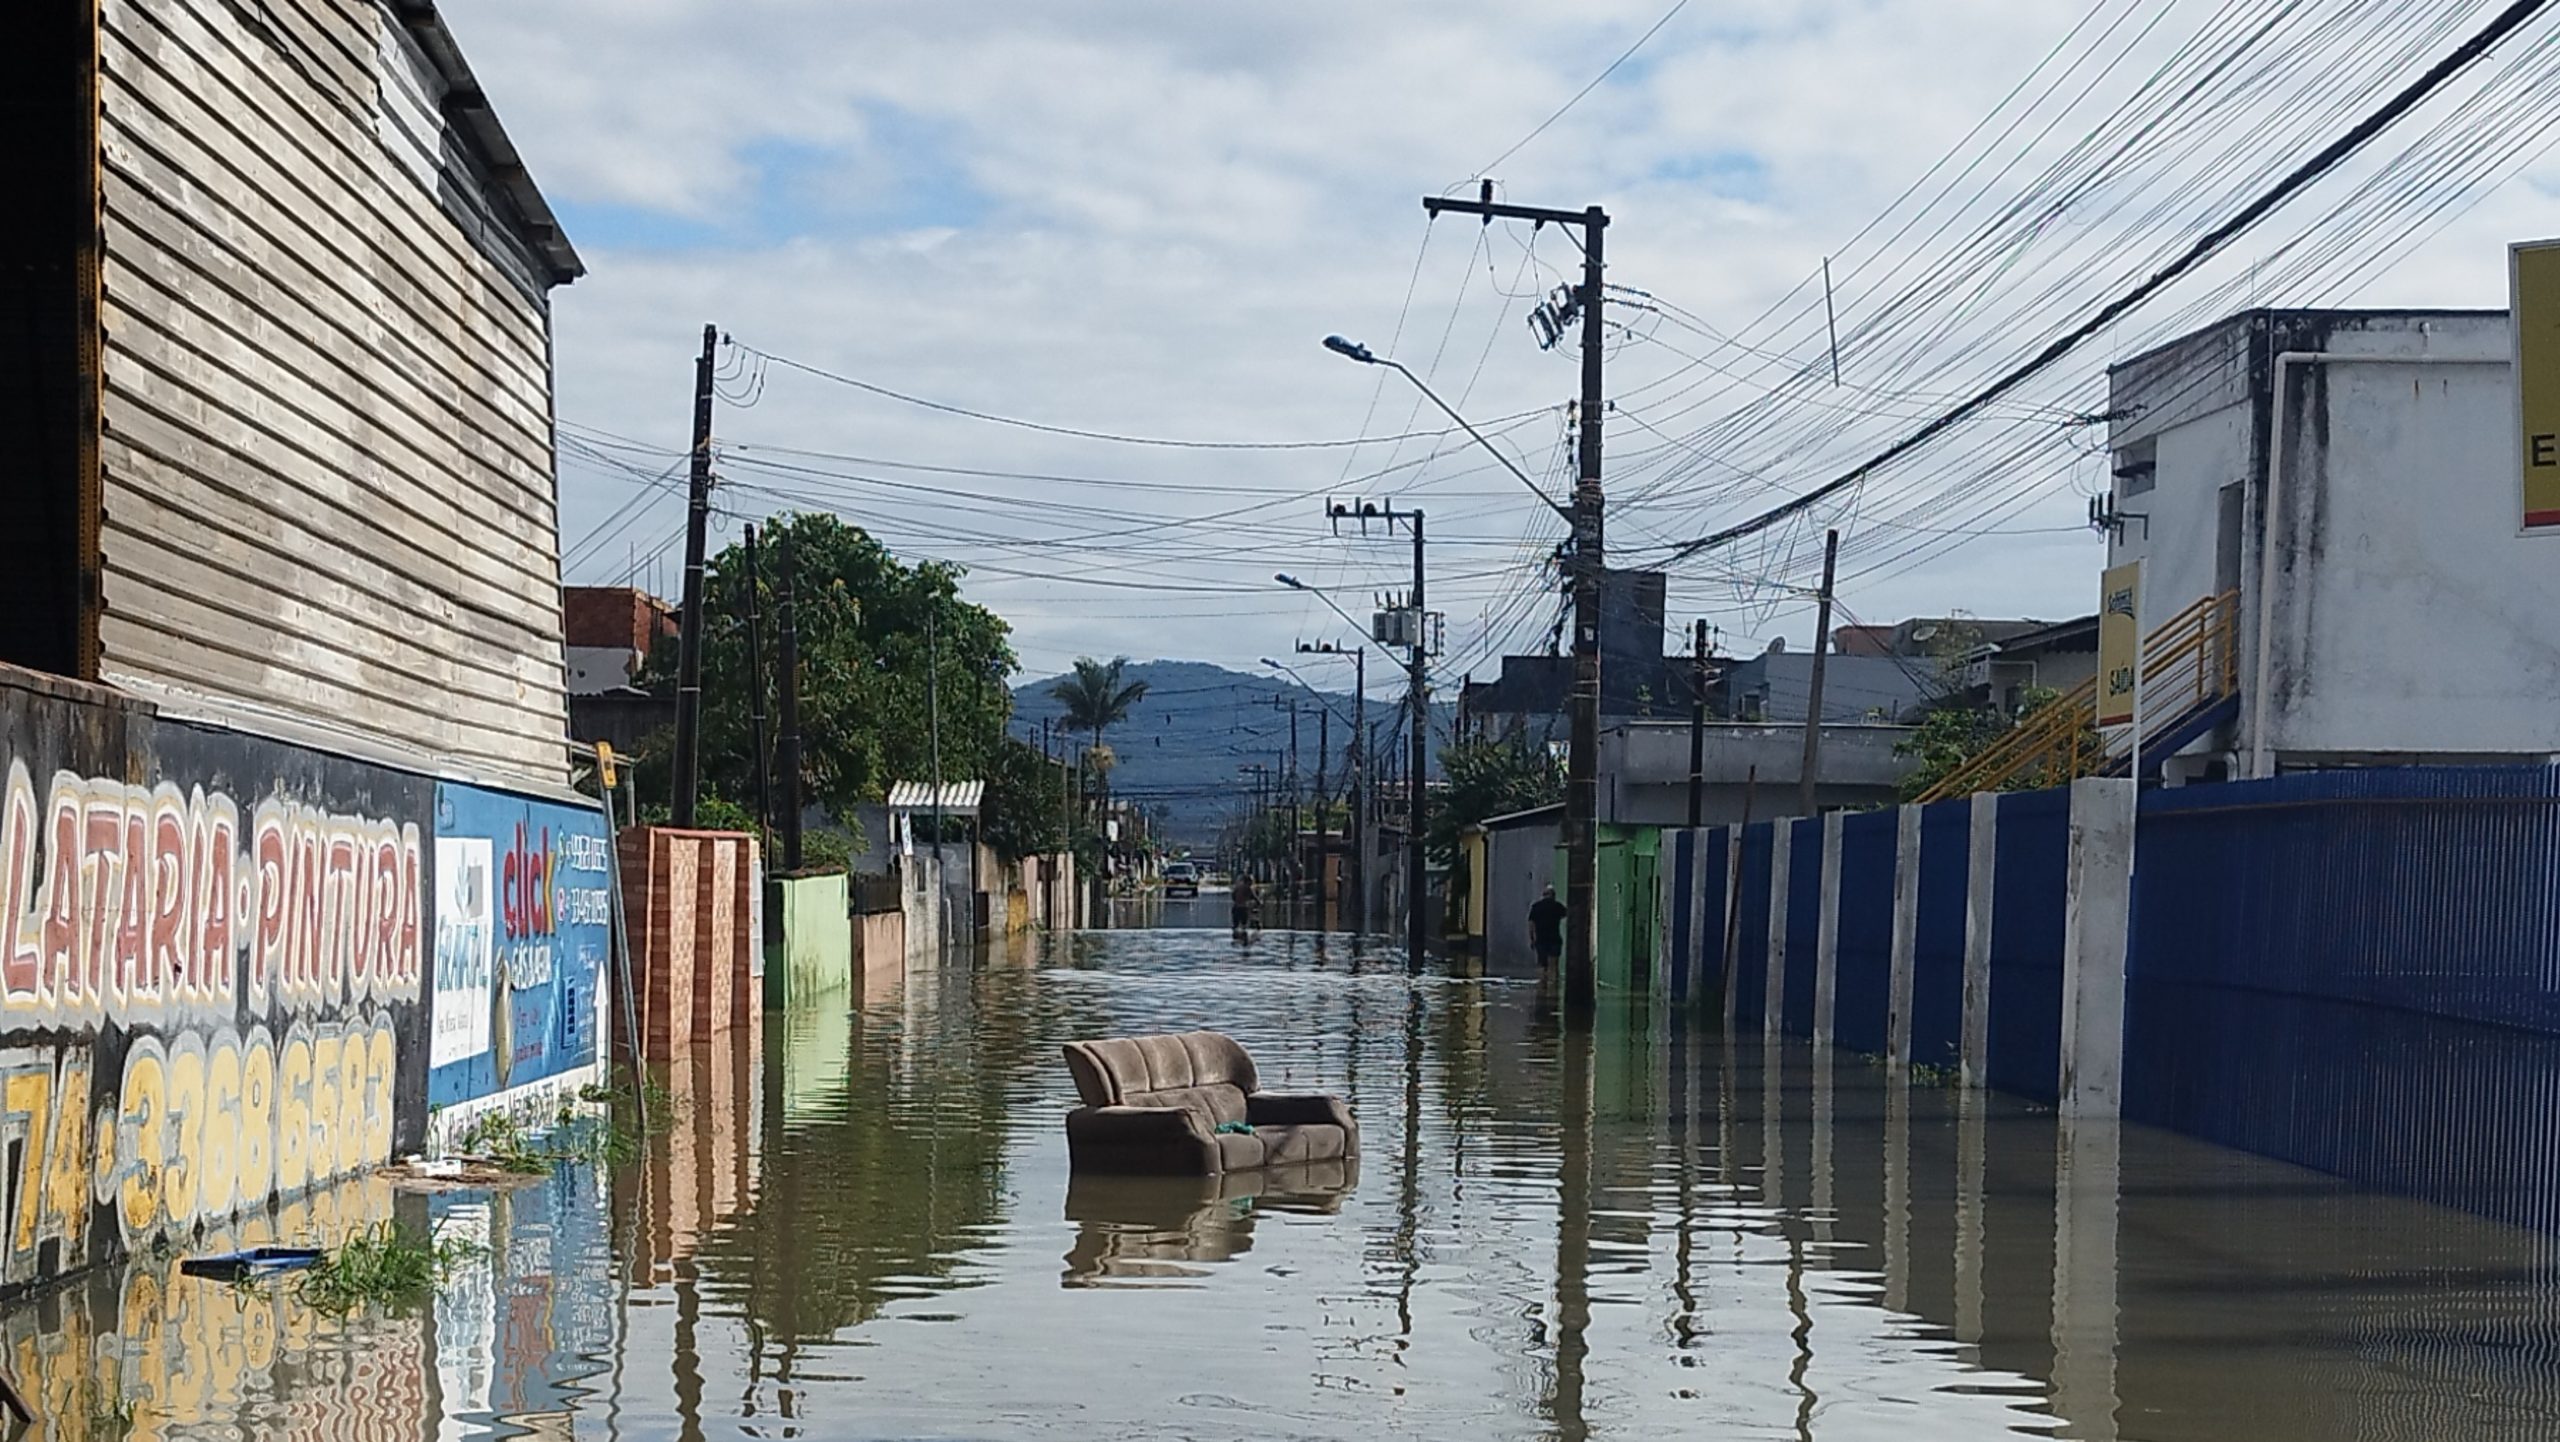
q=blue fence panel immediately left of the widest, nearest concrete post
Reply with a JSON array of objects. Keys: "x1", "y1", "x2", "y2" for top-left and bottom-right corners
[{"x1": 1989, "y1": 789, "x2": 2071, "y2": 1101}]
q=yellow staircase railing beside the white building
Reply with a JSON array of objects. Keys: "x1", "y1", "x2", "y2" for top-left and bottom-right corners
[{"x1": 1920, "y1": 592, "x2": 2240, "y2": 802}]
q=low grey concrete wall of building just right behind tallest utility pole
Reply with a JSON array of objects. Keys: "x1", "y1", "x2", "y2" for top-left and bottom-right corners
[{"x1": 1600, "y1": 722, "x2": 1912, "y2": 827}]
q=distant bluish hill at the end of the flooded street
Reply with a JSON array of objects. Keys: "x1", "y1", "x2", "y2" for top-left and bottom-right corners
[{"x1": 1014, "y1": 656, "x2": 1452, "y2": 845}]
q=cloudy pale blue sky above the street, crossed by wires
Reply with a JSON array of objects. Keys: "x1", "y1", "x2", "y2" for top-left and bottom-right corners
[{"x1": 440, "y1": 0, "x2": 2560, "y2": 686}]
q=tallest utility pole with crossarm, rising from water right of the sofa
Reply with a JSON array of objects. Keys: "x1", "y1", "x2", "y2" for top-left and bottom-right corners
[{"x1": 1416, "y1": 182, "x2": 1608, "y2": 1012}]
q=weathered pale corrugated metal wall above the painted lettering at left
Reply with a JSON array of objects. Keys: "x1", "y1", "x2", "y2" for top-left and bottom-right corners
[{"x1": 102, "y1": 0, "x2": 566, "y2": 779}]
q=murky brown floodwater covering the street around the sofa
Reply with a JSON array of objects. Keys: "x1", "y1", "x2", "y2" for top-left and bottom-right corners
[{"x1": 0, "y1": 927, "x2": 2560, "y2": 1442}]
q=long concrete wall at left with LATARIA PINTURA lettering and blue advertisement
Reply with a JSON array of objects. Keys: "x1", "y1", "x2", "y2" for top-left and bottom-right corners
[{"x1": 0, "y1": 668, "x2": 612, "y2": 1293}]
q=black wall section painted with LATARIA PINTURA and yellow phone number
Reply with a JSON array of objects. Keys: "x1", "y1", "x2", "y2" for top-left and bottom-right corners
[{"x1": 0, "y1": 689, "x2": 435, "y2": 1288}]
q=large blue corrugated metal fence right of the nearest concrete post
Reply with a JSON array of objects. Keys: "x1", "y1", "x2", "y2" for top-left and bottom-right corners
[{"x1": 2129, "y1": 766, "x2": 2560, "y2": 1229}]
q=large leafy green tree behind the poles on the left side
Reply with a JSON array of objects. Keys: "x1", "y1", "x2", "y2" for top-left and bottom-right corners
[{"x1": 640, "y1": 512, "x2": 1014, "y2": 832}]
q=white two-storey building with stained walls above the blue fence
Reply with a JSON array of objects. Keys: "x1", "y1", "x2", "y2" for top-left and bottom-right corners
[{"x1": 2109, "y1": 310, "x2": 2560, "y2": 779}]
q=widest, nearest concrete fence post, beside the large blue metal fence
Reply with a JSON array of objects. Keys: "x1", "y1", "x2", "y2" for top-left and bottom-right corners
[{"x1": 2056, "y1": 776, "x2": 2135, "y2": 1122}]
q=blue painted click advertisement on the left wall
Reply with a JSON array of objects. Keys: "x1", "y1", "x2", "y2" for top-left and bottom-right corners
[{"x1": 428, "y1": 781, "x2": 612, "y2": 1106}]
